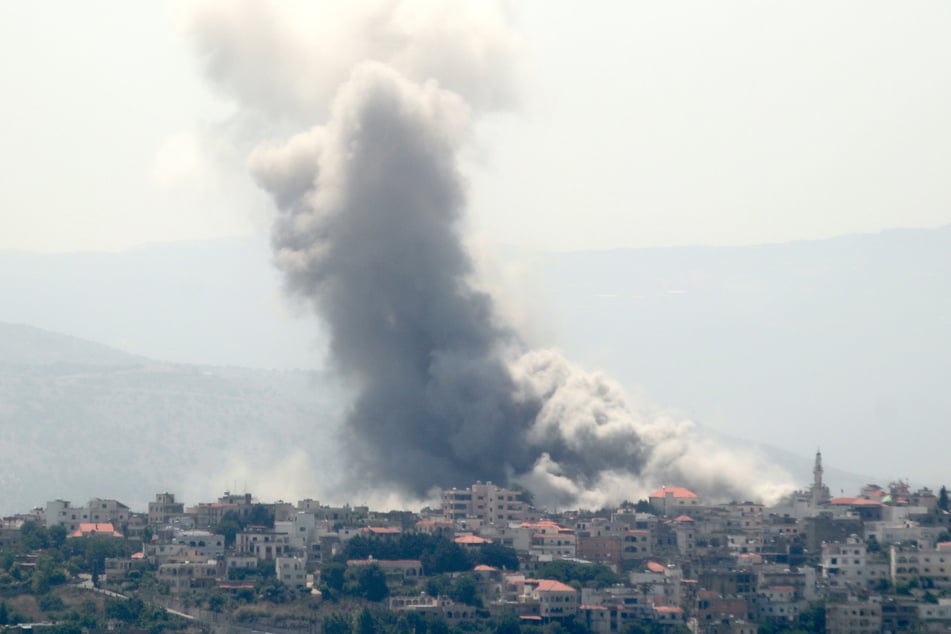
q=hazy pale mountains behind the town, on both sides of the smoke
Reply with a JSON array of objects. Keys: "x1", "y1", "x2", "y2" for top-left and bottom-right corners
[{"x1": 0, "y1": 227, "x2": 951, "y2": 510}]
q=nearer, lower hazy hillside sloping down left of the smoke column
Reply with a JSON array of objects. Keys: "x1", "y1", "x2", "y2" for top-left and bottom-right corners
[{"x1": 0, "y1": 324, "x2": 333, "y2": 513}]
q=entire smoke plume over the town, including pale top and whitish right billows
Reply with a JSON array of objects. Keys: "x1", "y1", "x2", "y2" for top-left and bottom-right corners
[{"x1": 182, "y1": 2, "x2": 783, "y2": 506}]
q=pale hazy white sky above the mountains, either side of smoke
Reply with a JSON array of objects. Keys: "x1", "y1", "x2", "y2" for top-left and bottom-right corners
[{"x1": 0, "y1": 0, "x2": 951, "y2": 251}]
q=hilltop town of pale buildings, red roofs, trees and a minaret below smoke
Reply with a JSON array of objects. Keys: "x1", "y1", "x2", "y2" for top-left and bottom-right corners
[{"x1": 0, "y1": 453, "x2": 951, "y2": 634}]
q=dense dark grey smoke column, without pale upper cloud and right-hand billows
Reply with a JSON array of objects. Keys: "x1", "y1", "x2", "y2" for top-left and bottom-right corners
[{"x1": 252, "y1": 64, "x2": 641, "y2": 494}]
